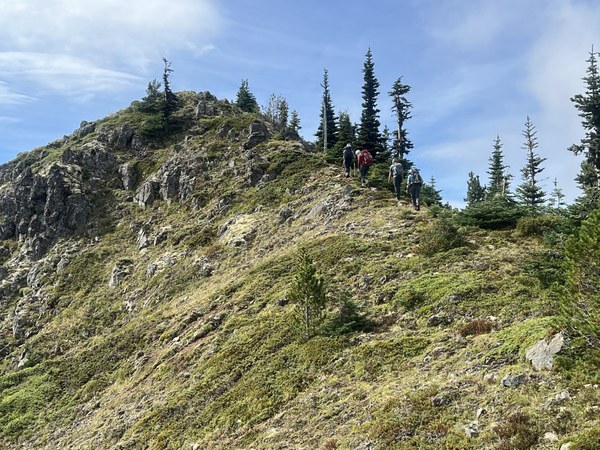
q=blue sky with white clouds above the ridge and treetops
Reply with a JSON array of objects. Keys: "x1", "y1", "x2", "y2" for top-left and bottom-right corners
[{"x1": 0, "y1": 0, "x2": 600, "y2": 206}]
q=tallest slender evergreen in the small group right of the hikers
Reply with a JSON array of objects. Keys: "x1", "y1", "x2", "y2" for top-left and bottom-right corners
[{"x1": 516, "y1": 116, "x2": 546, "y2": 208}]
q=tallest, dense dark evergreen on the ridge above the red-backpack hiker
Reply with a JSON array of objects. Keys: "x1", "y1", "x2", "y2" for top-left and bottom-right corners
[{"x1": 358, "y1": 48, "x2": 381, "y2": 155}]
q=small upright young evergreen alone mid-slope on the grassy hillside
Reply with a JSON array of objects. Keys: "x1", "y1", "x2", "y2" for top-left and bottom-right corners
[{"x1": 288, "y1": 250, "x2": 327, "y2": 340}]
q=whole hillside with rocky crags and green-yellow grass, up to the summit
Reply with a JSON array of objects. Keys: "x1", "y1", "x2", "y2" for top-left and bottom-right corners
[{"x1": 0, "y1": 92, "x2": 600, "y2": 450}]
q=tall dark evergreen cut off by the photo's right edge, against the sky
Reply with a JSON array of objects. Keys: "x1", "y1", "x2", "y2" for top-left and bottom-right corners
[{"x1": 569, "y1": 47, "x2": 600, "y2": 191}]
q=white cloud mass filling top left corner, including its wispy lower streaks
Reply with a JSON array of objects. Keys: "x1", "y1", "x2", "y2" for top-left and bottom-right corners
[{"x1": 0, "y1": 0, "x2": 220, "y2": 99}]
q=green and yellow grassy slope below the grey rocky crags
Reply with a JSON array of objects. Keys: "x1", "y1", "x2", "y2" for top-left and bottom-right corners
[{"x1": 0, "y1": 103, "x2": 600, "y2": 449}]
